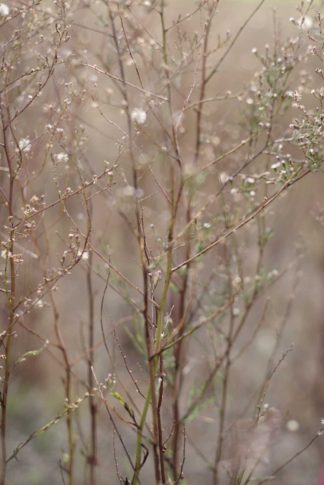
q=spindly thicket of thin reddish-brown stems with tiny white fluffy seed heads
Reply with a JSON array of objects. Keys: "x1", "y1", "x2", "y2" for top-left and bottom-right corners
[{"x1": 0, "y1": 0, "x2": 324, "y2": 485}]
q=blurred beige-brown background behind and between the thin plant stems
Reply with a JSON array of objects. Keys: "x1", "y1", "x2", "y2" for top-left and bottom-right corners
[{"x1": 0, "y1": 0, "x2": 324, "y2": 485}]
